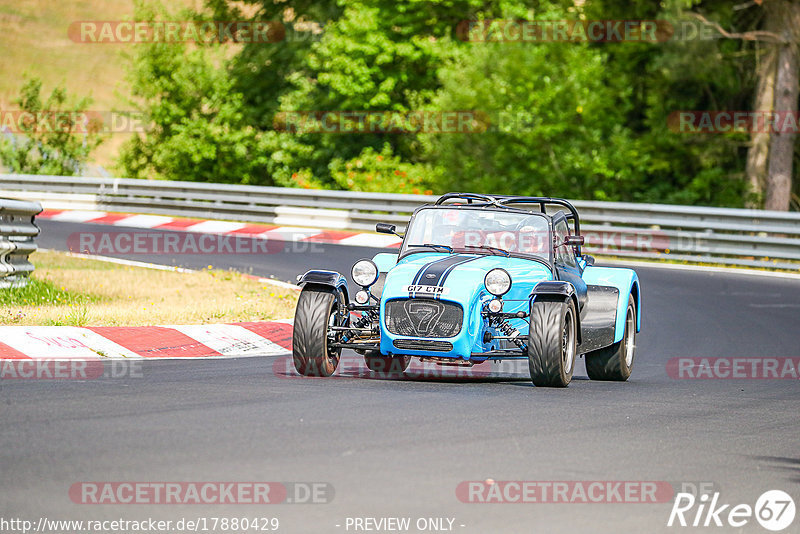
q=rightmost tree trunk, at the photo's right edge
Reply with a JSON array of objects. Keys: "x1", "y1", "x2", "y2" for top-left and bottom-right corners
[{"x1": 764, "y1": 0, "x2": 800, "y2": 211}]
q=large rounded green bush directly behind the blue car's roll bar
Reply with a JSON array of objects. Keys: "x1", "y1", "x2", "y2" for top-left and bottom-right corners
[{"x1": 426, "y1": 8, "x2": 647, "y2": 199}]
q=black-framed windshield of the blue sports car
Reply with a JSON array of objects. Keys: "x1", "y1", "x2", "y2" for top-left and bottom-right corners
[{"x1": 401, "y1": 207, "x2": 550, "y2": 261}]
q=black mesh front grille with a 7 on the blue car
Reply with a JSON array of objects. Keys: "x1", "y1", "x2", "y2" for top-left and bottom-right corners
[{"x1": 384, "y1": 298, "x2": 464, "y2": 338}]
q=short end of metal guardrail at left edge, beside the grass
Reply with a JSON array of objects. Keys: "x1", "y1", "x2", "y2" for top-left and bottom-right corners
[{"x1": 0, "y1": 198, "x2": 42, "y2": 288}]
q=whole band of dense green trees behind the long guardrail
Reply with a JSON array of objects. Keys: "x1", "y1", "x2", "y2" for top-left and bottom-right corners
[{"x1": 115, "y1": 0, "x2": 796, "y2": 206}]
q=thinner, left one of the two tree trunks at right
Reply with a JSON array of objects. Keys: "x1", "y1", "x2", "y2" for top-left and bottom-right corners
[{"x1": 746, "y1": 9, "x2": 780, "y2": 208}]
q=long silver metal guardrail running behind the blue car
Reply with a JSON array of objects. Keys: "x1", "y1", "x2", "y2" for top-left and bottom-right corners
[{"x1": 0, "y1": 174, "x2": 800, "y2": 269}]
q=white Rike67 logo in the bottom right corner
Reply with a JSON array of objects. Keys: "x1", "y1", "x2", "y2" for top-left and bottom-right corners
[{"x1": 667, "y1": 490, "x2": 795, "y2": 532}]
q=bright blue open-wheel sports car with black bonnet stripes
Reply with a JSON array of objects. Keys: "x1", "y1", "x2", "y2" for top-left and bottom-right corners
[{"x1": 292, "y1": 193, "x2": 641, "y2": 387}]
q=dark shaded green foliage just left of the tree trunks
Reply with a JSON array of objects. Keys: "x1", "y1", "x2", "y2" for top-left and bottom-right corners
[{"x1": 600, "y1": 0, "x2": 756, "y2": 206}]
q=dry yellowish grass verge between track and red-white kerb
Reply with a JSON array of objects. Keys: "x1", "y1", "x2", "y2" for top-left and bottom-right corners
[{"x1": 0, "y1": 251, "x2": 297, "y2": 326}]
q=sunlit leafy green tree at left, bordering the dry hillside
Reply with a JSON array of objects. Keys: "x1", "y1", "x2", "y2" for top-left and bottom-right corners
[{"x1": 119, "y1": 1, "x2": 273, "y2": 185}]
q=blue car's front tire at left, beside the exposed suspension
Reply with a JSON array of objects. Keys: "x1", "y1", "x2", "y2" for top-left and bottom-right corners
[{"x1": 292, "y1": 287, "x2": 347, "y2": 376}]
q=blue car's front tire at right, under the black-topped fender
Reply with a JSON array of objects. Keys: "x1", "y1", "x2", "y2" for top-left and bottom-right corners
[{"x1": 528, "y1": 299, "x2": 578, "y2": 388}]
